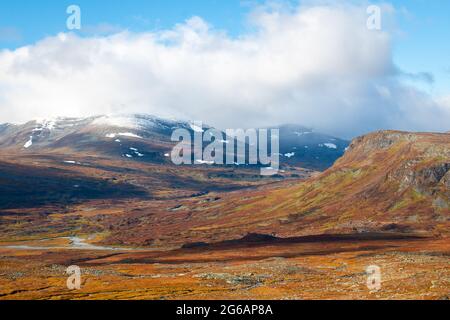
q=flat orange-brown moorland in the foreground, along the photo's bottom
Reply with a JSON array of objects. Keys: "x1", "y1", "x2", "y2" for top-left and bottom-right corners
[{"x1": 0, "y1": 239, "x2": 450, "y2": 300}]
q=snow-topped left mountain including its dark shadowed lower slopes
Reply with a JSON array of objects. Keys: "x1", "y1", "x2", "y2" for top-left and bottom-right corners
[{"x1": 0, "y1": 115, "x2": 311, "y2": 211}]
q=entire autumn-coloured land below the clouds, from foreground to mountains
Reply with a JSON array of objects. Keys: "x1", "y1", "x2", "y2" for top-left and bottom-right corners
[{"x1": 0, "y1": 116, "x2": 450, "y2": 300}]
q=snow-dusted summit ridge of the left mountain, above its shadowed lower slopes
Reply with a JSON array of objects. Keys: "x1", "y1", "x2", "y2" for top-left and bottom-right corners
[{"x1": 0, "y1": 115, "x2": 190, "y2": 162}]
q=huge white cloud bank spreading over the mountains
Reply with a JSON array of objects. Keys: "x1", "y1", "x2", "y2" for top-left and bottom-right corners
[{"x1": 0, "y1": 4, "x2": 450, "y2": 137}]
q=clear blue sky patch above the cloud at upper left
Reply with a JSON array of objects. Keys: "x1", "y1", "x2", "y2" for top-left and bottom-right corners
[{"x1": 0, "y1": 0, "x2": 256, "y2": 43}]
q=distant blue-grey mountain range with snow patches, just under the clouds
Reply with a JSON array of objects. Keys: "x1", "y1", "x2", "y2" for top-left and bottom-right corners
[{"x1": 0, "y1": 114, "x2": 349, "y2": 170}]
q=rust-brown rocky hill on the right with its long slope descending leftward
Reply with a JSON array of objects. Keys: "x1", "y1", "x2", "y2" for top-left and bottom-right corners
[{"x1": 99, "y1": 131, "x2": 450, "y2": 244}]
